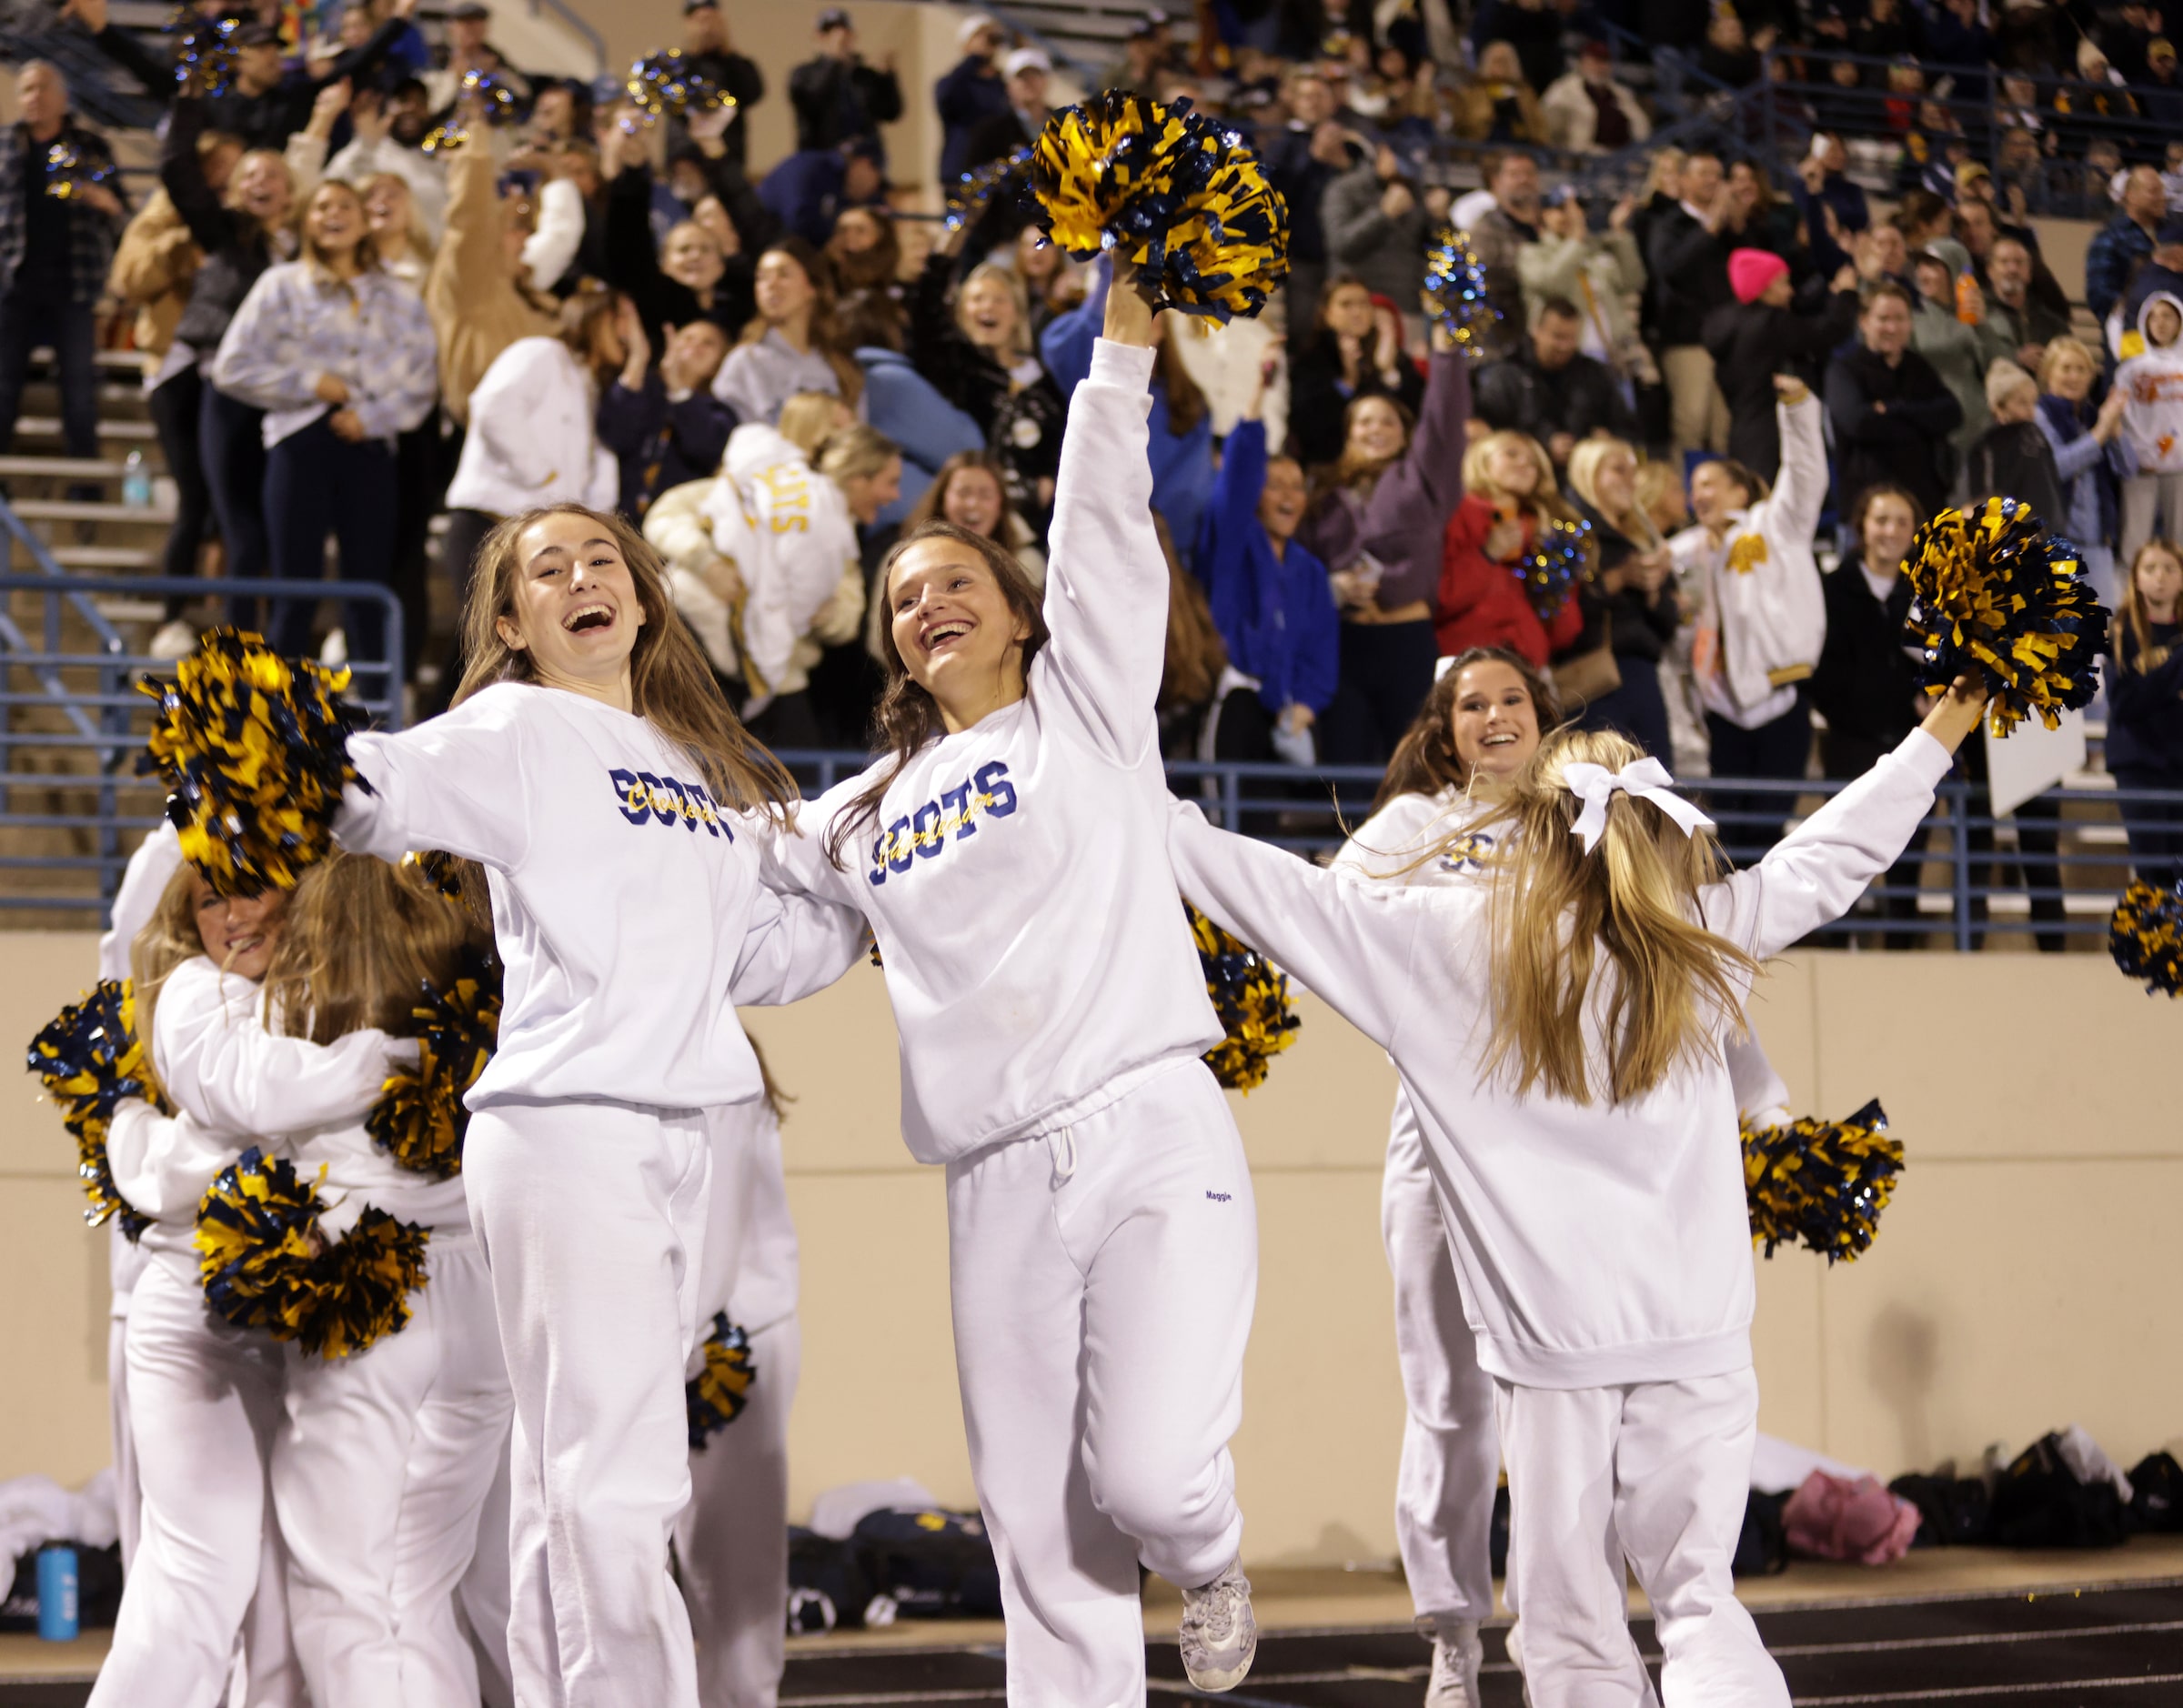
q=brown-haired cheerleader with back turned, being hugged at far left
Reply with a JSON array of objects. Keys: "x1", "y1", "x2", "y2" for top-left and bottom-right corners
[{"x1": 236, "y1": 854, "x2": 513, "y2": 1708}]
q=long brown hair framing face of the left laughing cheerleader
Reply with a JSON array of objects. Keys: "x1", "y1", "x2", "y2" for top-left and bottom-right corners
[{"x1": 452, "y1": 505, "x2": 797, "y2": 819}]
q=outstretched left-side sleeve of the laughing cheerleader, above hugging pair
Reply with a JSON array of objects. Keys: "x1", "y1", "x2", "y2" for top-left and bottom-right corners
[{"x1": 334, "y1": 688, "x2": 552, "y2": 871}]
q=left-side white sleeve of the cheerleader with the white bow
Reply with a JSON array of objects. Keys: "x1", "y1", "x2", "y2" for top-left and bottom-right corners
[{"x1": 1168, "y1": 801, "x2": 1423, "y2": 1049}]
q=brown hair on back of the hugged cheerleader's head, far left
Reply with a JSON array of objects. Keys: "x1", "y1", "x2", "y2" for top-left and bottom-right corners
[{"x1": 267, "y1": 852, "x2": 491, "y2": 1044}]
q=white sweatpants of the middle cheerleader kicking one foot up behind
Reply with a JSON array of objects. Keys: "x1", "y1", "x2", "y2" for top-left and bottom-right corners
[{"x1": 948, "y1": 1061, "x2": 1257, "y2": 1708}]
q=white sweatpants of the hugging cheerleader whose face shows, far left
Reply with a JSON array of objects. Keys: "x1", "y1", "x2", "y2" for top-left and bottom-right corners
[{"x1": 92, "y1": 1261, "x2": 304, "y2": 1708}]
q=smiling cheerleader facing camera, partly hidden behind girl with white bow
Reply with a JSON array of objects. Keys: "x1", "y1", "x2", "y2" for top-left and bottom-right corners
[{"x1": 1333, "y1": 647, "x2": 1788, "y2": 1708}]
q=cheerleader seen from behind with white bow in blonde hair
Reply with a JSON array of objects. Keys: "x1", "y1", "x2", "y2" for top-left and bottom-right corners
[{"x1": 1170, "y1": 684, "x2": 1982, "y2": 1708}]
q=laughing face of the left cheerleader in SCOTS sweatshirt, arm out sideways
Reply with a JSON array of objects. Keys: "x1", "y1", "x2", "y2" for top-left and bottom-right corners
[{"x1": 493, "y1": 511, "x2": 644, "y2": 701}]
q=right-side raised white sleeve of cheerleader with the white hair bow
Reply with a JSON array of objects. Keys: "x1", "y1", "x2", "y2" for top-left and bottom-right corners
[{"x1": 1698, "y1": 729, "x2": 1949, "y2": 978}]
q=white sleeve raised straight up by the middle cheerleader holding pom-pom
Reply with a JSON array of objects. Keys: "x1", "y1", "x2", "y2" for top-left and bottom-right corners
[{"x1": 1037, "y1": 338, "x2": 1188, "y2": 765}]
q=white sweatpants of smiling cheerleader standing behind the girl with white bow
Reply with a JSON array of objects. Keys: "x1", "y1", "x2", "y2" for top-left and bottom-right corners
[{"x1": 1380, "y1": 1090, "x2": 1500, "y2": 1630}]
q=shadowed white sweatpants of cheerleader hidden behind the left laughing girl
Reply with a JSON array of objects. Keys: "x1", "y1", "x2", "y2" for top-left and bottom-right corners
[{"x1": 675, "y1": 1317, "x2": 803, "y2": 1708}]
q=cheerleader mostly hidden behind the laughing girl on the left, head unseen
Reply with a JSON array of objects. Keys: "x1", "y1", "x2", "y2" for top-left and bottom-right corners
[{"x1": 675, "y1": 1044, "x2": 803, "y2": 1708}]
